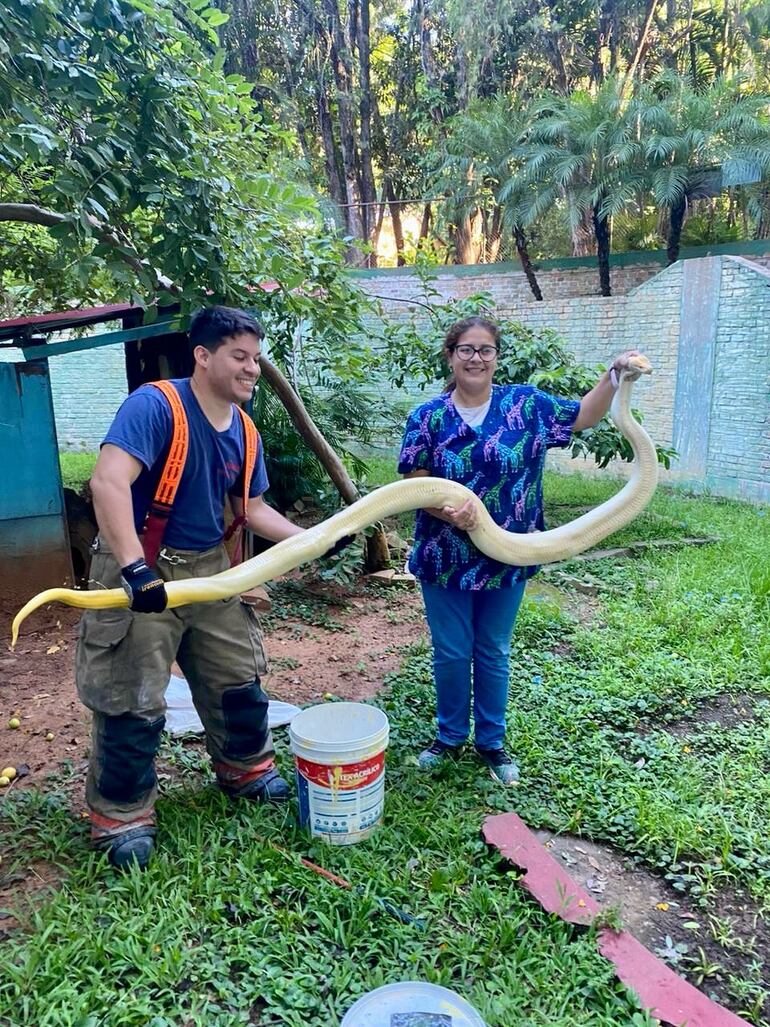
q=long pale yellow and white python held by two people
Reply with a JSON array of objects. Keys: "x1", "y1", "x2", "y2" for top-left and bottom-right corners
[{"x1": 11, "y1": 354, "x2": 658, "y2": 645}]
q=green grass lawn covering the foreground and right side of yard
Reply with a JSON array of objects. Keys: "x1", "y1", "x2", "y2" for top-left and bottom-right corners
[{"x1": 0, "y1": 467, "x2": 770, "y2": 1027}]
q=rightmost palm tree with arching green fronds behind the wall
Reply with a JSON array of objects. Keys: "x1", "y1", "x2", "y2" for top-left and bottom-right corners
[{"x1": 628, "y1": 72, "x2": 770, "y2": 264}]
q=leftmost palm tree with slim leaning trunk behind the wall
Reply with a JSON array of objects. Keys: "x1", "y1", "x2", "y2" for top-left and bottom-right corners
[{"x1": 431, "y1": 97, "x2": 543, "y2": 300}]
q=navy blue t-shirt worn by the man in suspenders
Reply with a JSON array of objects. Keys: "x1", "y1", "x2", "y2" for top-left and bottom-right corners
[{"x1": 102, "y1": 378, "x2": 269, "y2": 551}]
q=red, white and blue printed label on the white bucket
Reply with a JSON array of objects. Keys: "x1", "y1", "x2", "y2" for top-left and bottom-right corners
[{"x1": 295, "y1": 753, "x2": 385, "y2": 845}]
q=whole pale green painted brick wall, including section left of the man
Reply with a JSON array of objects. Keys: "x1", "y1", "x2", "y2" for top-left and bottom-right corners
[{"x1": 0, "y1": 248, "x2": 770, "y2": 501}]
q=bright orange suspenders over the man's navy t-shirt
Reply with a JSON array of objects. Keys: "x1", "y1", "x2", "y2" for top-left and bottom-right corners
[{"x1": 142, "y1": 381, "x2": 260, "y2": 567}]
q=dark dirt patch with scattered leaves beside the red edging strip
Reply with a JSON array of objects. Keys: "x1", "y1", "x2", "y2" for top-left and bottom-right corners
[{"x1": 536, "y1": 831, "x2": 770, "y2": 1019}]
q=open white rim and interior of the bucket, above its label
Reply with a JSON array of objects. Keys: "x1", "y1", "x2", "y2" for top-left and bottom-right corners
[{"x1": 288, "y1": 702, "x2": 388, "y2": 753}]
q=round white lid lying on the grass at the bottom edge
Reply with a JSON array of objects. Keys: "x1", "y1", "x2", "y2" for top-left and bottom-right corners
[{"x1": 340, "y1": 981, "x2": 486, "y2": 1027}]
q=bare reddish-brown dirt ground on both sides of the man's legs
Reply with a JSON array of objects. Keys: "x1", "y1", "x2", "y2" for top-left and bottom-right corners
[{"x1": 0, "y1": 579, "x2": 427, "y2": 788}]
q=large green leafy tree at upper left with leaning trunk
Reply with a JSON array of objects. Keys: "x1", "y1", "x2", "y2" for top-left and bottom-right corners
[{"x1": 0, "y1": 0, "x2": 392, "y2": 554}]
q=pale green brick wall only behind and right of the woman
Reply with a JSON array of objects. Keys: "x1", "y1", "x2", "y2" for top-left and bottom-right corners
[{"x1": 361, "y1": 256, "x2": 770, "y2": 501}]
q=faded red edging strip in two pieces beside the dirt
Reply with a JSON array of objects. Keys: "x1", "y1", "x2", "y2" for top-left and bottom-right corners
[{"x1": 482, "y1": 813, "x2": 749, "y2": 1027}]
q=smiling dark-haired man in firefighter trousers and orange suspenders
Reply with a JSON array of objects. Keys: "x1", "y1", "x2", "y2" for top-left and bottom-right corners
[{"x1": 76, "y1": 306, "x2": 302, "y2": 867}]
